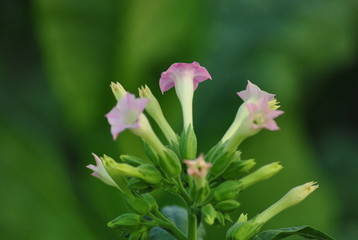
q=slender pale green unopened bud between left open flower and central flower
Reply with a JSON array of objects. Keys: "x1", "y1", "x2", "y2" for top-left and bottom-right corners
[{"x1": 139, "y1": 85, "x2": 179, "y2": 146}]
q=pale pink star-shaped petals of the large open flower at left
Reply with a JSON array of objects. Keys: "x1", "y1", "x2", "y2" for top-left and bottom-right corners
[{"x1": 106, "y1": 93, "x2": 149, "y2": 139}]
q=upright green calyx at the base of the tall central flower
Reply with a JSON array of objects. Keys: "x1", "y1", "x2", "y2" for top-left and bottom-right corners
[{"x1": 179, "y1": 124, "x2": 197, "y2": 159}]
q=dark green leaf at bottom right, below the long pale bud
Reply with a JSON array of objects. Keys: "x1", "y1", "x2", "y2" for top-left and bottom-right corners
[{"x1": 252, "y1": 226, "x2": 334, "y2": 240}]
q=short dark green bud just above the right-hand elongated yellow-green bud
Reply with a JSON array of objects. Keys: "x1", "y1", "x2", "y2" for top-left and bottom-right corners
[{"x1": 222, "y1": 159, "x2": 256, "y2": 179}]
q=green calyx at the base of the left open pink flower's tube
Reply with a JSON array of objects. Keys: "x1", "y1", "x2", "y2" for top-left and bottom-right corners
[{"x1": 159, "y1": 148, "x2": 182, "y2": 177}]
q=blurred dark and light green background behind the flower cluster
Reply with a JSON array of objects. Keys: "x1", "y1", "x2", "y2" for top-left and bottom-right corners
[{"x1": 0, "y1": 0, "x2": 358, "y2": 240}]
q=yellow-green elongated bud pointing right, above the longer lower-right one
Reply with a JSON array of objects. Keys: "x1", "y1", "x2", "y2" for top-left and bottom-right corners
[{"x1": 240, "y1": 162, "x2": 283, "y2": 189}]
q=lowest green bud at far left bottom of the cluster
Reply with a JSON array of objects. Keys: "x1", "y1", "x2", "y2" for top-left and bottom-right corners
[{"x1": 108, "y1": 213, "x2": 142, "y2": 231}]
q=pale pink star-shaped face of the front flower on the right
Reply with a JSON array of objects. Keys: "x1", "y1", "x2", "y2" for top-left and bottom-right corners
[{"x1": 246, "y1": 96, "x2": 283, "y2": 131}]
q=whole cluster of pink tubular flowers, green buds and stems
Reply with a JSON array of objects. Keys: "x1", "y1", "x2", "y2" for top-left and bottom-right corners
[{"x1": 88, "y1": 62, "x2": 328, "y2": 240}]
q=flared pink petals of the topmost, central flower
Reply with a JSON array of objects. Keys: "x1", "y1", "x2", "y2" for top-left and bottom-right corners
[{"x1": 159, "y1": 62, "x2": 211, "y2": 93}]
